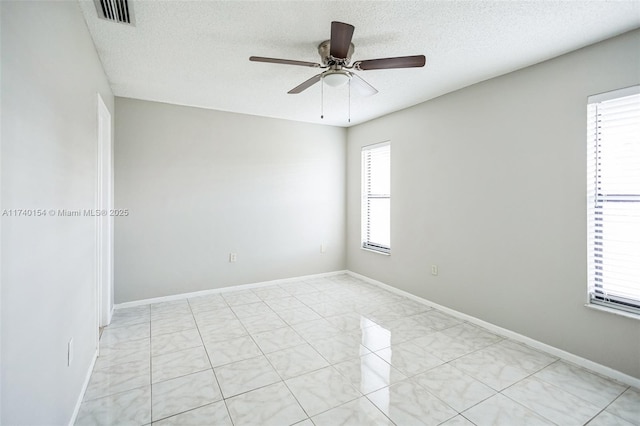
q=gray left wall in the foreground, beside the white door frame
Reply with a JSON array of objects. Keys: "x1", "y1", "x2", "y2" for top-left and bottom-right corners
[{"x1": 0, "y1": 1, "x2": 113, "y2": 425}]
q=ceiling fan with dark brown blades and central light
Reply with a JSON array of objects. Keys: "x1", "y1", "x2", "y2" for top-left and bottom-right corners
[{"x1": 249, "y1": 21, "x2": 425, "y2": 95}]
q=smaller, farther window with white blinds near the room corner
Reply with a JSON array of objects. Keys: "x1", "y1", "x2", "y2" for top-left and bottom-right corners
[{"x1": 361, "y1": 142, "x2": 391, "y2": 254}]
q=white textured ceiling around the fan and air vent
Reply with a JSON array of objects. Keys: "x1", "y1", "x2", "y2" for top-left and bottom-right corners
[{"x1": 80, "y1": 0, "x2": 640, "y2": 126}]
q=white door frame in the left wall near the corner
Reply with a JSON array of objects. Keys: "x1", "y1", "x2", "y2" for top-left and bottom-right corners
[{"x1": 96, "y1": 93, "x2": 113, "y2": 350}]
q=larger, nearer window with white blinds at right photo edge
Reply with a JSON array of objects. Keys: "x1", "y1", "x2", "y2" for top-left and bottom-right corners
[{"x1": 587, "y1": 86, "x2": 640, "y2": 314}]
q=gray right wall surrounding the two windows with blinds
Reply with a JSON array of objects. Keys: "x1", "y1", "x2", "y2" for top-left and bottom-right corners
[{"x1": 347, "y1": 31, "x2": 640, "y2": 377}]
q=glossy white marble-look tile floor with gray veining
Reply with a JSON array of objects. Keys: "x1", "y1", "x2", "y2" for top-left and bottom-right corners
[{"x1": 76, "y1": 275, "x2": 640, "y2": 426}]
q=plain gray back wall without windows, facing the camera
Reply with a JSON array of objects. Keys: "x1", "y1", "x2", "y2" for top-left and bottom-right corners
[{"x1": 115, "y1": 97, "x2": 346, "y2": 303}]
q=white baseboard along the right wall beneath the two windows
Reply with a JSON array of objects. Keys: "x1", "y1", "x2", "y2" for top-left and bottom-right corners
[{"x1": 347, "y1": 271, "x2": 640, "y2": 389}]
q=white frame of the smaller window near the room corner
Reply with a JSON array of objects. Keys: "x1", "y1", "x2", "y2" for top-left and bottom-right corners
[{"x1": 360, "y1": 141, "x2": 391, "y2": 256}]
